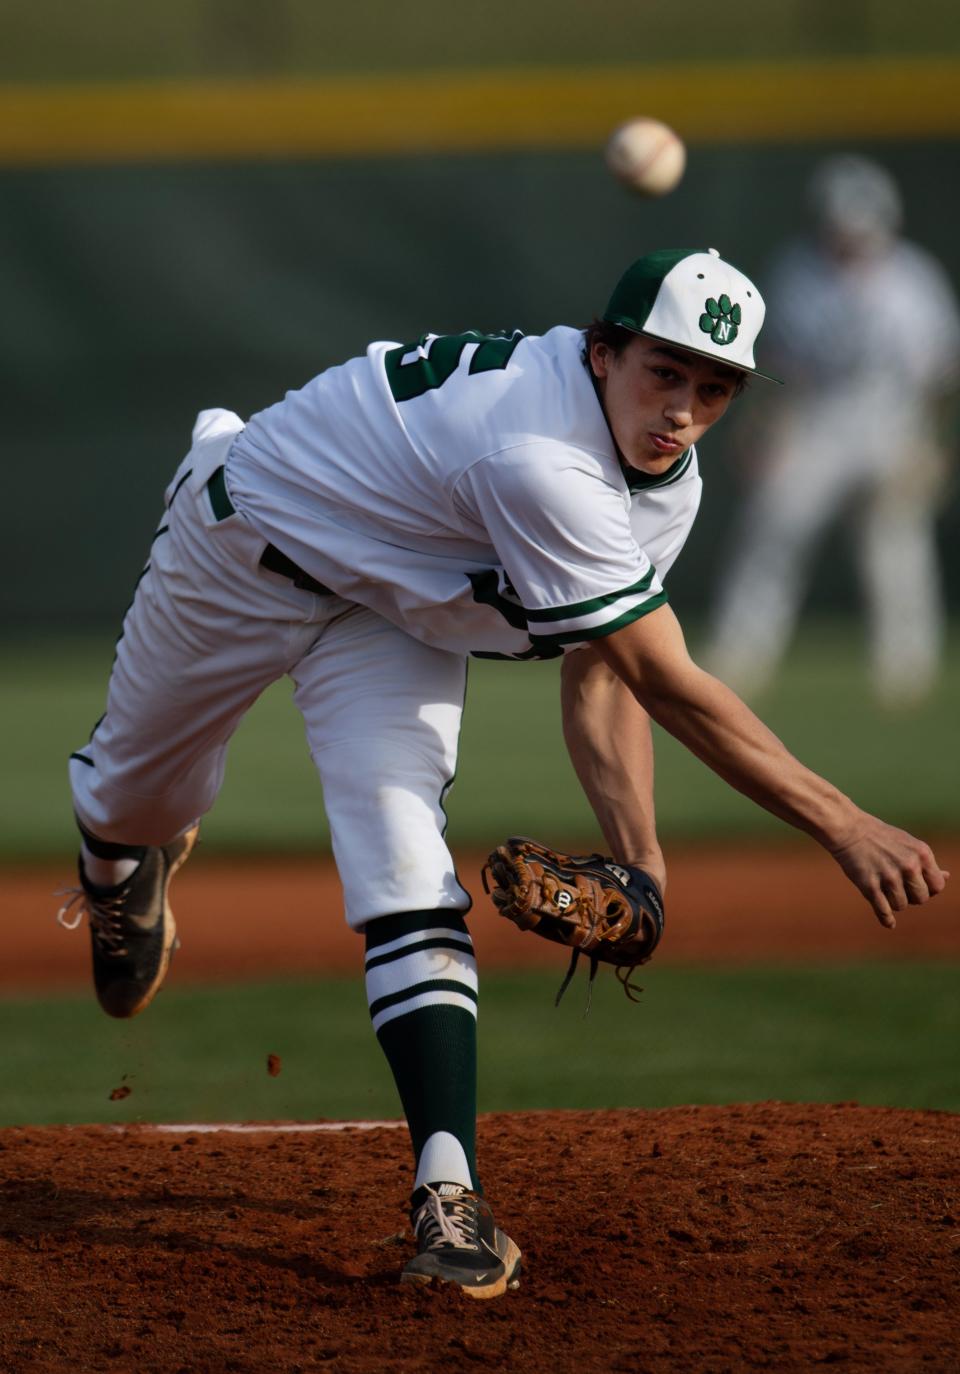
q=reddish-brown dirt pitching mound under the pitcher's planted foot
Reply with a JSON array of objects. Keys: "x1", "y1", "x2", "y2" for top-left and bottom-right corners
[{"x1": 0, "y1": 1103, "x2": 960, "y2": 1374}]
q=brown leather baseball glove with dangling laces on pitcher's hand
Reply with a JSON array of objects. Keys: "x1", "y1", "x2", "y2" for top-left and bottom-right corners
[{"x1": 481, "y1": 835, "x2": 663, "y2": 1009}]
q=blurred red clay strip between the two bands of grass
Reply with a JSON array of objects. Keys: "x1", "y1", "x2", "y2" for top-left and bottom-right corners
[{"x1": 7, "y1": 837, "x2": 960, "y2": 991}]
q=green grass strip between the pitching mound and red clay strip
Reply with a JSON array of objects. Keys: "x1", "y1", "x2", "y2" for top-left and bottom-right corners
[{"x1": 0, "y1": 960, "x2": 960, "y2": 1127}]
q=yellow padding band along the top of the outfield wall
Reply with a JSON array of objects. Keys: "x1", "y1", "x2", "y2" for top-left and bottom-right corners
[{"x1": 0, "y1": 59, "x2": 960, "y2": 166}]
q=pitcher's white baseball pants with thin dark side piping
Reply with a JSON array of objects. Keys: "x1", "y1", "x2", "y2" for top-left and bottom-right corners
[{"x1": 70, "y1": 411, "x2": 470, "y2": 927}]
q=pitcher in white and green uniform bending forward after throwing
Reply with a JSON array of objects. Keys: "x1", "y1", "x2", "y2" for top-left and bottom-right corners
[{"x1": 62, "y1": 249, "x2": 946, "y2": 1298}]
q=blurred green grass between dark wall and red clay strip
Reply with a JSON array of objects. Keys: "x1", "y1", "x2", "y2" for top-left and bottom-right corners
[{"x1": 0, "y1": 625, "x2": 960, "y2": 861}]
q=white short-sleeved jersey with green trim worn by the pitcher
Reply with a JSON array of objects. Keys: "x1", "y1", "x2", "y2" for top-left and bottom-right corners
[{"x1": 225, "y1": 327, "x2": 700, "y2": 658}]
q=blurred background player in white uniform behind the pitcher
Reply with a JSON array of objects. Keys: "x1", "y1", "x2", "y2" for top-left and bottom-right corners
[{"x1": 705, "y1": 157, "x2": 960, "y2": 705}]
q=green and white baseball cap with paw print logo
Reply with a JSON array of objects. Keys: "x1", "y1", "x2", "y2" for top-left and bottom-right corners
[{"x1": 603, "y1": 249, "x2": 780, "y2": 382}]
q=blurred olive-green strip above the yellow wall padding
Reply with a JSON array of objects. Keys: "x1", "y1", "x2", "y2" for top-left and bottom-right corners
[{"x1": 7, "y1": 0, "x2": 960, "y2": 81}]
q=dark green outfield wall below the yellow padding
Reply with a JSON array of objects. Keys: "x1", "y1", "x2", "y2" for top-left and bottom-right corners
[{"x1": 0, "y1": 135, "x2": 960, "y2": 631}]
